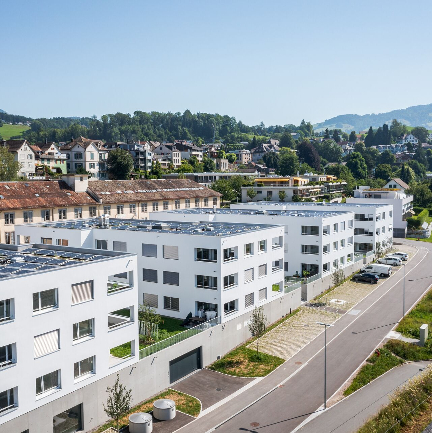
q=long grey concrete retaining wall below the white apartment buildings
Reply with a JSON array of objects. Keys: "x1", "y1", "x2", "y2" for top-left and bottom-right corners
[{"x1": 0, "y1": 289, "x2": 301, "y2": 433}]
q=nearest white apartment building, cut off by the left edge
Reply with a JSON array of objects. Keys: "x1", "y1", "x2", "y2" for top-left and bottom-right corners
[{"x1": 0, "y1": 242, "x2": 138, "y2": 426}]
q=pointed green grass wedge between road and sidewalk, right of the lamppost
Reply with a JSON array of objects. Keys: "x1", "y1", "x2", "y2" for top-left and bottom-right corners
[{"x1": 344, "y1": 348, "x2": 404, "y2": 396}]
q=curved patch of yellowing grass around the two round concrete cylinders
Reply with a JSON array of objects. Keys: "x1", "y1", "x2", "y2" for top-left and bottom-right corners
[{"x1": 96, "y1": 389, "x2": 201, "y2": 433}]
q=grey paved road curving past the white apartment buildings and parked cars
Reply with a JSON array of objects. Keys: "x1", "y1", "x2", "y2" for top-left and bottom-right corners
[{"x1": 176, "y1": 241, "x2": 432, "y2": 433}]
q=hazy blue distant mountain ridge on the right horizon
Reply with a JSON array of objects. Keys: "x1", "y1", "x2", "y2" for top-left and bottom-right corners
[{"x1": 314, "y1": 104, "x2": 432, "y2": 132}]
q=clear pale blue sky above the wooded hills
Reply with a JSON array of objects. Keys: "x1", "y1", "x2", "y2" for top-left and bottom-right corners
[{"x1": 0, "y1": 0, "x2": 432, "y2": 125}]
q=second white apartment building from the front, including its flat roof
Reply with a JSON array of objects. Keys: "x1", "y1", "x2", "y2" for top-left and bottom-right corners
[{"x1": 16, "y1": 219, "x2": 284, "y2": 322}]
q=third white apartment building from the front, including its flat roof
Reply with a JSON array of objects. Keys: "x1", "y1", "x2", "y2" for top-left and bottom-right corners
[{"x1": 151, "y1": 209, "x2": 354, "y2": 276}]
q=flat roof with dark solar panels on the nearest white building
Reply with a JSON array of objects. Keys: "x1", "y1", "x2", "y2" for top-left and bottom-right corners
[{"x1": 0, "y1": 244, "x2": 131, "y2": 281}]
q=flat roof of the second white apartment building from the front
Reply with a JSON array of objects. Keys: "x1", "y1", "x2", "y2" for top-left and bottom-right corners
[{"x1": 25, "y1": 218, "x2": 280, "y2": 238}]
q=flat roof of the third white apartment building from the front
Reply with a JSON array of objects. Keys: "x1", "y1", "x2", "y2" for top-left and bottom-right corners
[{"x1": 160, "y1": 208, "x2": 350, "y2": 218}]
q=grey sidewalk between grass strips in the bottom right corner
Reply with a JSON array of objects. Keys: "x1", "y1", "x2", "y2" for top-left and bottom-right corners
[{"x1": 296, "y1": 361, "x2": 429, "y2": 433}]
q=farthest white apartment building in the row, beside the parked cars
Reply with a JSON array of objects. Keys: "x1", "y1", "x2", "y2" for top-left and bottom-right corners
[{"x1": 231, "y1": 199, "x2": 393, "y2": 253}]
